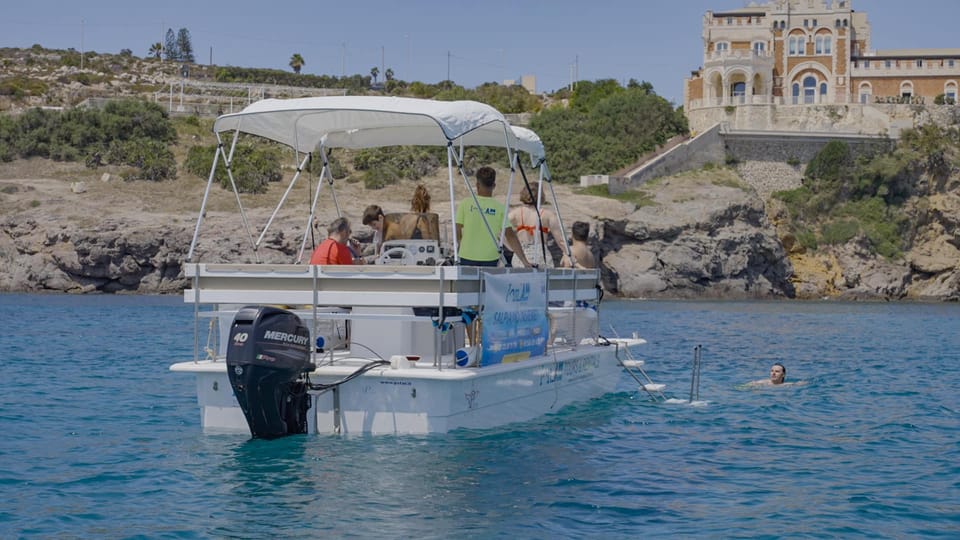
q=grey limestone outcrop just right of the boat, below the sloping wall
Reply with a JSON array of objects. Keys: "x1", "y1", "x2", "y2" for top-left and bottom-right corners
[{"x1": 602, "y1": 173, "x2": 794, "y2": 297}]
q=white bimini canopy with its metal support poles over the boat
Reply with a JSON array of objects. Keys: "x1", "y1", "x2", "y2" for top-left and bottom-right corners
[{"x1": 187, "y1": 96, "x2": 562, "y2": 261}]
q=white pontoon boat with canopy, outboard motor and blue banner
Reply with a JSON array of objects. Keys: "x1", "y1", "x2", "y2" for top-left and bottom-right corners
[{"x1": 170, "y1": 97, "x2": 649, "y2": 438}]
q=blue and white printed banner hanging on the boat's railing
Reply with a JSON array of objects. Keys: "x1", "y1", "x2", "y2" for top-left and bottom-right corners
[{"x1": 480, "y1": 272, "x2": 550, "y2": 366}]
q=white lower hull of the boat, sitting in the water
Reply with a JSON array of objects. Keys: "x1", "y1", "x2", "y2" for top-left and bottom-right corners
[{"x1": 171, "y1": 345, "x2": 623, "y2": 434}]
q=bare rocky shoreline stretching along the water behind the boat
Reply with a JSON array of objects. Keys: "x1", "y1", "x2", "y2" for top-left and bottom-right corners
[{"x1": 0, "y1": 158, "x2": 960, "y2": 301}]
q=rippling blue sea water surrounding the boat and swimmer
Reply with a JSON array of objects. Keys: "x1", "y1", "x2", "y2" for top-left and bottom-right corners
[{"x1": 0, "y1": 295, "x2": 960, "y2": 539}]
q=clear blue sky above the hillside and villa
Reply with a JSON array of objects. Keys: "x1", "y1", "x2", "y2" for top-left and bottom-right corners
[{"x1": 0, "y1": 0, "x2": 960, "y2": 104}]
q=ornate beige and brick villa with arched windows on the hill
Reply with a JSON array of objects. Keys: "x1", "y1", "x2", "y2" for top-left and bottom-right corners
[{"x1": 684, "y1": 0, "x2": 960, "y2": 130}]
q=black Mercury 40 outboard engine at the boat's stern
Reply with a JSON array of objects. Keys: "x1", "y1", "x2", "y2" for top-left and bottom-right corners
[{"x1": 227, "y1": 306, "x2": 314, "y2": 439}]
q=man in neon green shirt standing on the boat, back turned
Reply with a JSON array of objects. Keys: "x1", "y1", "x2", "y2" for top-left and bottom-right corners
[{"x1": 456, "y1": 167, "x2": 531, "y2": 266}]
